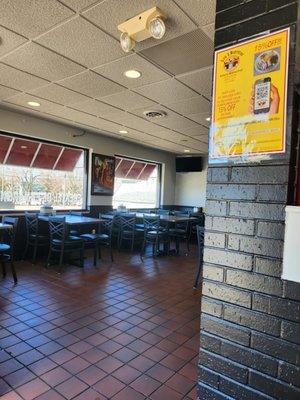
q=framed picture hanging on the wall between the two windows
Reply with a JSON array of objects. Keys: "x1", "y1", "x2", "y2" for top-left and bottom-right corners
[{"x1": 91, "y1": 153, "x2": 115, "y2": 196}]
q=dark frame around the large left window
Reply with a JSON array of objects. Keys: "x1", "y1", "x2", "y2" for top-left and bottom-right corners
[{"x1": 0, "y1": 130, "x2": 90, "y2": 215}]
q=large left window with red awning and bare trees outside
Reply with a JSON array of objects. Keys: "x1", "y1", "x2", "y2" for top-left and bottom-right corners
[{"x1": 0, "y1": 133, "x2": 87, "y2": 210}]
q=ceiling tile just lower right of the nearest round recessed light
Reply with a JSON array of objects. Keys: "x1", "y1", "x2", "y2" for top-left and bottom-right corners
[{"x1": 135, "y1": 79, "x2": 195, "y2": 104}]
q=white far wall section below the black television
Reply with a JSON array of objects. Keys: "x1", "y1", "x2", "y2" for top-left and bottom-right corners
[{"x1": 175, "y1": 158, "x2": 207, "y2": 207}]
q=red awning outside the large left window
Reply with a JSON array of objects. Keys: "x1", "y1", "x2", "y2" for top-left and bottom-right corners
[{"x1": 0, "y1": 135, "x2": 83, "y2": 171}]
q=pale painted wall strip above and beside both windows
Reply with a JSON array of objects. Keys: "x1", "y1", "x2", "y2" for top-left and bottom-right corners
[{"x1": 0, "y1": 109, "x2": 175, "y2": 205}]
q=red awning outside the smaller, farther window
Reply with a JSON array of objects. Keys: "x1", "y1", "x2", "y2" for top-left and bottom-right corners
[{"x1": 115, "y1": 157, "x2": 157, "y2": 181}]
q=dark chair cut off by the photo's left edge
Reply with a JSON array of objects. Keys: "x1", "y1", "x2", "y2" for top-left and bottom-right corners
[{"x1": 0, "y1": 217, "x2": 19, "y2": 284}]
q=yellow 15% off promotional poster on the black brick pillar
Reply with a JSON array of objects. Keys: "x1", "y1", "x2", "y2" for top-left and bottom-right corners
[{"x1": 209, "y1": 28, "x2": 289, "y2": 162}]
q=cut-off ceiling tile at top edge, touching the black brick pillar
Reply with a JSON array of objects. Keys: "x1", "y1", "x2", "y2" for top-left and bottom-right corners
[{"x1": 175, "y1": 0, "x2": 216, "y2": 26}]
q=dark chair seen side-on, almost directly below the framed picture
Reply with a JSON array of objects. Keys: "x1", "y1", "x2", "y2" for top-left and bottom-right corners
[{"x1": 80, "y1": 214, "x2": 116, "y2": 266}]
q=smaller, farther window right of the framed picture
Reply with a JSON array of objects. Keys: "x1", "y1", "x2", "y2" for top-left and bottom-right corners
[{"x1": 113, "y1": 157, "x2": 160, "y2": 208}]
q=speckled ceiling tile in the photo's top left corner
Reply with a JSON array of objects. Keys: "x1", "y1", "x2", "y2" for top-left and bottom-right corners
[{"x1": 0, "y1": 0, "x2": 74, "y2": 38}]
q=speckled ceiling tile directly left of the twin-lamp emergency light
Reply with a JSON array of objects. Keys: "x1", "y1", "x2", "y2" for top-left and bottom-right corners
[{"x1": 37, "y1": 17, "x2": 125, "y2": 68}]
